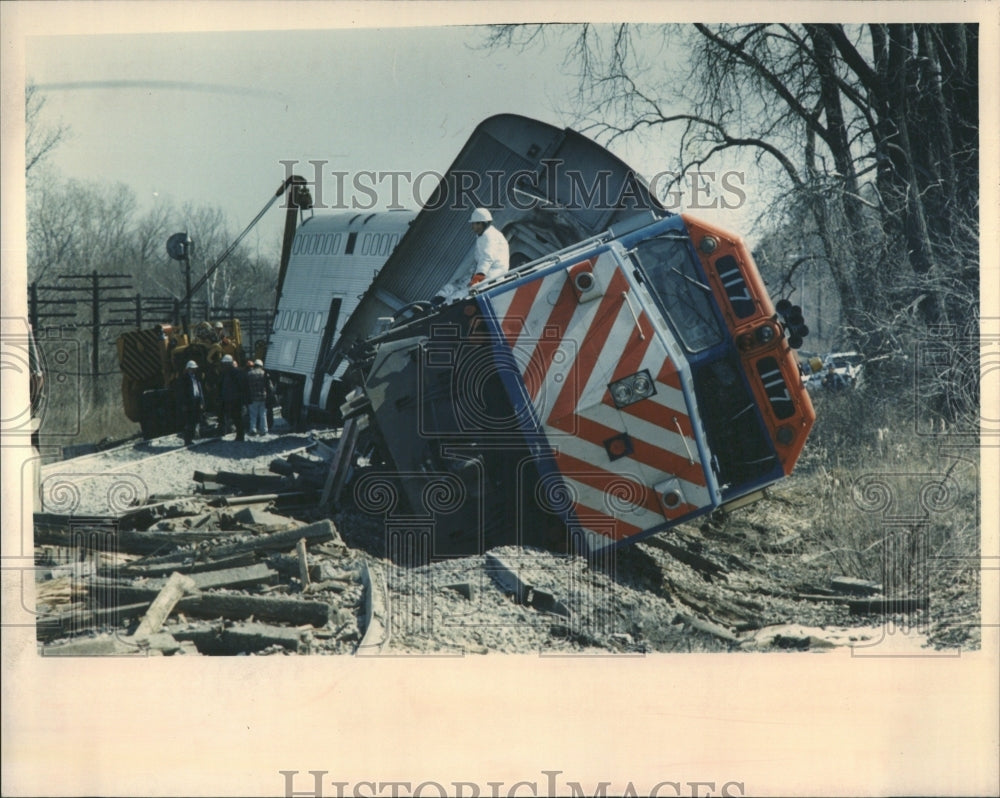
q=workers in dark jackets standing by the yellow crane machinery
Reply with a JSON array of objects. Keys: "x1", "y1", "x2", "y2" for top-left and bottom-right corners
[{"x1": 177, "y1": 354, "x2": 275, "y2": 446}]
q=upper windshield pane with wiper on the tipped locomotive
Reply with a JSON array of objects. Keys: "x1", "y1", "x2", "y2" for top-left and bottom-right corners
[{"x1": 633, "y1": 236, "x2": 724, "y2": 352}]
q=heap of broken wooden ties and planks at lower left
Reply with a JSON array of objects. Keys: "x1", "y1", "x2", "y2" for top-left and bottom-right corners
[{"x1": 36, "y1": 478, "x2": 363, "y2": 656}]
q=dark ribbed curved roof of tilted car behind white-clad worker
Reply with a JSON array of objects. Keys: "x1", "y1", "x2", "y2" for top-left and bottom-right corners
[{"x1": 337, "y1": 114, "x2": 670, "y2": 364}]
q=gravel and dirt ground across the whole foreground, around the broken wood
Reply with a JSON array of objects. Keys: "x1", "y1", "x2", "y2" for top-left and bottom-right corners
[{"x1": 36, "y1": 418, "x2": 980, "y2": 656}]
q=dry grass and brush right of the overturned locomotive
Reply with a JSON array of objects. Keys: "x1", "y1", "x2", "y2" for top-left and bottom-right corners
[{"x1": 764, "y1": 393, "x2": 981, "y2": 645}]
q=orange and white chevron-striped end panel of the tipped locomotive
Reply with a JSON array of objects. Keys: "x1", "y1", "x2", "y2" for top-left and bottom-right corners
[{"x1": 490, "y1": 253, "x2": 712, "y2": 548}]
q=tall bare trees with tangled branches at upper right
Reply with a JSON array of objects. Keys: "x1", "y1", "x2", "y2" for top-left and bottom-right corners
[{"x1": 488, "y1": 23, "x2": 979, "y2": 422}]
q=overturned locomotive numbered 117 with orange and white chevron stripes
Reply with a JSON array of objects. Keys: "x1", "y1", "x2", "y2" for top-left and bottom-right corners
[{"x1": 342, "y1": 209, "x2": 815, "y2": 555}]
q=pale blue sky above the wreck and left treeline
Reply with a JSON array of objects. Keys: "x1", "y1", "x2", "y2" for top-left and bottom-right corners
[{"x1": 26, "y1": 26, "x2": 756, "y2": 251}]
